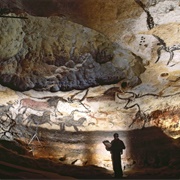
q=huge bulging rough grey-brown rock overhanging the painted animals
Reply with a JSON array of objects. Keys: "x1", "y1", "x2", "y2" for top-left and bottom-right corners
[{"x1": 0, "y1": 14, "x2": 141, "y2": 92}]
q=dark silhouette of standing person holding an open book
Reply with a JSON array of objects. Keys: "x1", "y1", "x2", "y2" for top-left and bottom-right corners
[{"x1": 106, "y1": 133, "x2": 126, "y2": 178}]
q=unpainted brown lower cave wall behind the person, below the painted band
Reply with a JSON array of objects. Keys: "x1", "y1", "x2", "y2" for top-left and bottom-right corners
[{"x1": 10, "y1": 127, "x2": 180, "y2": 169}]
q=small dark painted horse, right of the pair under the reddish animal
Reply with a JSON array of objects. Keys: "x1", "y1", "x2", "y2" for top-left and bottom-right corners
[{"x1": 55, "y1": 110, "x2": 86, "y2": 131}]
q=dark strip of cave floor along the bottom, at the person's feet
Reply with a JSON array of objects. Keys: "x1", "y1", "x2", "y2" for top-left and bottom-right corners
[{"x1": 0, "y1": 161, "x2": 180, "y2": 179}]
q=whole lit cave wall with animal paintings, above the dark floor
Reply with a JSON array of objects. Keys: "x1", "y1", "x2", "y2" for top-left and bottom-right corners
[{"x1": 0, "y1": 0, "x2": 180, "y2": 169}]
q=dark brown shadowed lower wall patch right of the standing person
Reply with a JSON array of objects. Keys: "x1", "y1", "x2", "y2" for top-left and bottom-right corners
[{"x1": 125, "y1": 127, "x2": 180, "y2": 168}]
